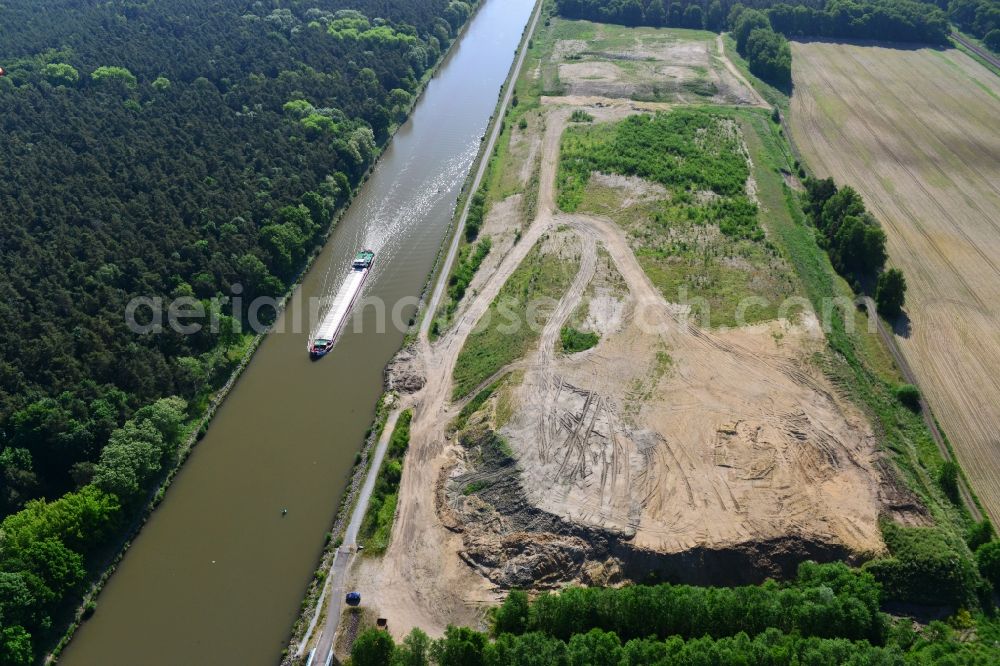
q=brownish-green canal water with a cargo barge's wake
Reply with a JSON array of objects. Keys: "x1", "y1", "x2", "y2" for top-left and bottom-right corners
[{"x1": 60, "y1": 0, "x2": 534, "y2": 666}]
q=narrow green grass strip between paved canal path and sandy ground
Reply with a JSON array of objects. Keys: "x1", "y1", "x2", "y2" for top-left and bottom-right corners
[{"x1": 358, "y1": 409, "x2": 413, "y2": 555}]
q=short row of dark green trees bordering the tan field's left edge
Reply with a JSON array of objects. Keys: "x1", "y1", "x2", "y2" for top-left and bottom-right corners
[{"x1": 804, "y1": 178, "x2": 906, "y2": 318}]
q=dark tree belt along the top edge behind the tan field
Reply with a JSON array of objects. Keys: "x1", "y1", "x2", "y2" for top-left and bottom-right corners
[{"x1": 556, "y1": 0, "x2": 952, "y2": 43}]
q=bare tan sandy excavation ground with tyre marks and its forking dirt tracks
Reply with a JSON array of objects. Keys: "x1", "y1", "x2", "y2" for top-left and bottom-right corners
[{"x1": 351, "y1": 98, "x2": 909, "y2": 636}]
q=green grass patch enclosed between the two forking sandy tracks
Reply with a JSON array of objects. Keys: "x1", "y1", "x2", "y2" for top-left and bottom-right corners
[{"x1": 453, "y1": 241, "x2": 575, "y2": 400}]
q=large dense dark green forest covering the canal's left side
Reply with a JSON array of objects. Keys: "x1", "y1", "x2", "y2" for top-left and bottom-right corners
[{"x1": 0, "y1": 0, "x2": 477, "y2": 665}]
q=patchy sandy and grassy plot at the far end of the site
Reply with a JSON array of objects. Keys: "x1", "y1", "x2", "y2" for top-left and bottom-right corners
[{"x1": 536, "y1": 19, "x2": 754, "y2": 104}]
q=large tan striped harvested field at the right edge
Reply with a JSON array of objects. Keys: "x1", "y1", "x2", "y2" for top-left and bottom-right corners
[{"x1": 791, "y1": 43, "x2": 1000, "y2": 521}]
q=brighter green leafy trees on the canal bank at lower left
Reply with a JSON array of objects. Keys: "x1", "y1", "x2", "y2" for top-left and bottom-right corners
[{"x1": 0, "y1": 398, "x2": 186, "y2": 666}]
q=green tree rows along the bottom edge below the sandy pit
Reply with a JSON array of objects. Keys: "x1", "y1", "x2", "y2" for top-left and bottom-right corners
[{"x1": 351, "y1": 563, "x2": 1000, "y2": 666}]
